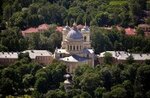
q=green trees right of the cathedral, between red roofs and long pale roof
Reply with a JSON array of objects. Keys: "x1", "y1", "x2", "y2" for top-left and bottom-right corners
[{"x1": 91, "y1": 26, "x2": 150, "y2": 53}]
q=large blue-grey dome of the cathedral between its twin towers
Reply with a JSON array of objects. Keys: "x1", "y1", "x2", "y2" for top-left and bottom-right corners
[{"x1": 67, "y1": 29, "x2": 83, "y2": 40}]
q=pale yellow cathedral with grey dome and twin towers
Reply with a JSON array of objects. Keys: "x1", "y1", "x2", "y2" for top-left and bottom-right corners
[{"x1": 54, "y1": 23, "x2": 95, "y2": 73}]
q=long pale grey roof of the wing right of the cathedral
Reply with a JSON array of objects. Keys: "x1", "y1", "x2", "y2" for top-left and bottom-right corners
[{"x1": 99, "y1": 51, "x2": 150, "y2": 60}]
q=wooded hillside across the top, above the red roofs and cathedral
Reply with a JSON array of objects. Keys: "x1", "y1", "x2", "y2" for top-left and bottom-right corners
[{"x1": 0, "y1": 0, "x2": 146, "y2": 29}]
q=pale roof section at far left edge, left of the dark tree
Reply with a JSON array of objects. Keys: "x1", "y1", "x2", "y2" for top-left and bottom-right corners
[{"x1": 0, "y1": 52, "x2": 18, "y2": 59}]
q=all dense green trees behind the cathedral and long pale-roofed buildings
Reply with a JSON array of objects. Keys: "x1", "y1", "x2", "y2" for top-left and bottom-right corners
[{"x1": 0, "y1": 0, "x2": 150, "y2": 53}]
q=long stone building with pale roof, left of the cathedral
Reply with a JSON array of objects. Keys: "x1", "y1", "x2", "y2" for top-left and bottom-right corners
[{"x1": 0, "y1": 50, "x2": 53, "y2": 65}]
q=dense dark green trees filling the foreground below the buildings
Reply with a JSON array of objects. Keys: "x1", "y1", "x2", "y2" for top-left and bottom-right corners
[{"x1": 0, "y1": 54, "x2": 150, "y2": 98}]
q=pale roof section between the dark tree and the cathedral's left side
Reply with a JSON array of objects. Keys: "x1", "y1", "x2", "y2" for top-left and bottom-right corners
[{"x1": 22, "y1": 50, "x2": 52, "y2": 59}]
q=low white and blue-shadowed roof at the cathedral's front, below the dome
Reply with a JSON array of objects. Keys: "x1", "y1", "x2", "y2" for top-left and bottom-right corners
[{"x1": 60, "y1": 55, "x2": 88, "y2": 62}]
